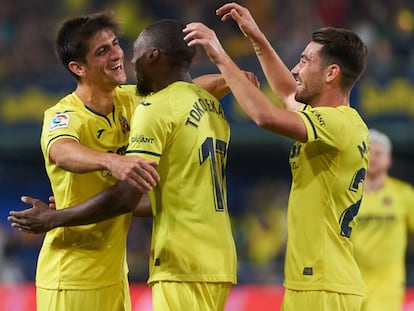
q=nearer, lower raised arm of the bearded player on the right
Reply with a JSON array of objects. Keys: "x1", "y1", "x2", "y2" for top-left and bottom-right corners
[{"x1": 184, "y1": 23, "x2": 307, "y2": 142}]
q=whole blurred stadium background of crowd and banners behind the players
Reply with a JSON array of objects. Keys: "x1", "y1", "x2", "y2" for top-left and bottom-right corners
[{"x1": 0, "y1": 0, "x2": 414, "y2": 311}]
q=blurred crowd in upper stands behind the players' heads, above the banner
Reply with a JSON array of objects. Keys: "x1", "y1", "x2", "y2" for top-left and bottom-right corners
[{"x1": 0, "y1": 0, "x2": 414, "y2": 88}]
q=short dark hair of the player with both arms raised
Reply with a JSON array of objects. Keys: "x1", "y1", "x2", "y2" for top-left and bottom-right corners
[{"x1": 312, "y1": 27, "x2": 367, "y2": 89}]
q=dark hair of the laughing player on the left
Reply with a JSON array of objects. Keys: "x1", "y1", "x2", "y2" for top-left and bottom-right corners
[{"x1": 55, "y1": 12, "x2": 120, "y2": 78}]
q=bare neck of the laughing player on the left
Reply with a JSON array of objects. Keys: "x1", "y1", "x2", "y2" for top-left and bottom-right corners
[{"x1": 75, "y1": 84, "x2": 114, "y2": 115}]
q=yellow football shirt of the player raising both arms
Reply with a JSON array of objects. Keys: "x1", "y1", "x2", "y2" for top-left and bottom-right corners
[{"x1": 284, "y1": 106, "x2": 369, "y2": 295}]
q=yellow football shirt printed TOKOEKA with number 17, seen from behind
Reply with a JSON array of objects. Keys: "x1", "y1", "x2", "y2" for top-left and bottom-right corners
[{"x1": 127, "y1": 82, "x2": 237, "y2": 283}]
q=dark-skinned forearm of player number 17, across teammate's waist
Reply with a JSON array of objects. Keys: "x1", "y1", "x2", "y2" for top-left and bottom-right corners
[{"x1": 49, "y1": 182, "x2": 142, "y2": 228}]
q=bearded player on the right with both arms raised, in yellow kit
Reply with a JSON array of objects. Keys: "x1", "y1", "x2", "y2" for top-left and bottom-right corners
[{"x1": 185, "y1": 3, "x2": 369, "y2": 311}]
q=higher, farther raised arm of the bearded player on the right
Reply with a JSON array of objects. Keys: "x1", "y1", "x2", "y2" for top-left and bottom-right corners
[{"x1": 216, "y1": 3, "x2": 300, "y2": 111}]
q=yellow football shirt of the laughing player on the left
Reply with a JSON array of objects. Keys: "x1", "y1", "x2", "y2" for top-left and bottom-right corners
[{"x1": 36, "y1": 86, "x2": 136, "y2": 289}]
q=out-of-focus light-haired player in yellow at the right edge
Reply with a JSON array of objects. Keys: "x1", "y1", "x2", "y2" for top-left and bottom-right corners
[{"x1": 351, "y1": 129, "x2": 414, "y2": 311}]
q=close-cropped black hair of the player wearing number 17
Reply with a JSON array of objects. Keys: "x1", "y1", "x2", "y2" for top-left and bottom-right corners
[{"x1": 143, "y1": 19, "x2": 196, "y2": 68}]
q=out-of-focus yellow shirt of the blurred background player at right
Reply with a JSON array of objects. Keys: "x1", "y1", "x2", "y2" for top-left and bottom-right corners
[{"x1": 351, "y1": 177, "x2": 414, "y2": 310}]
